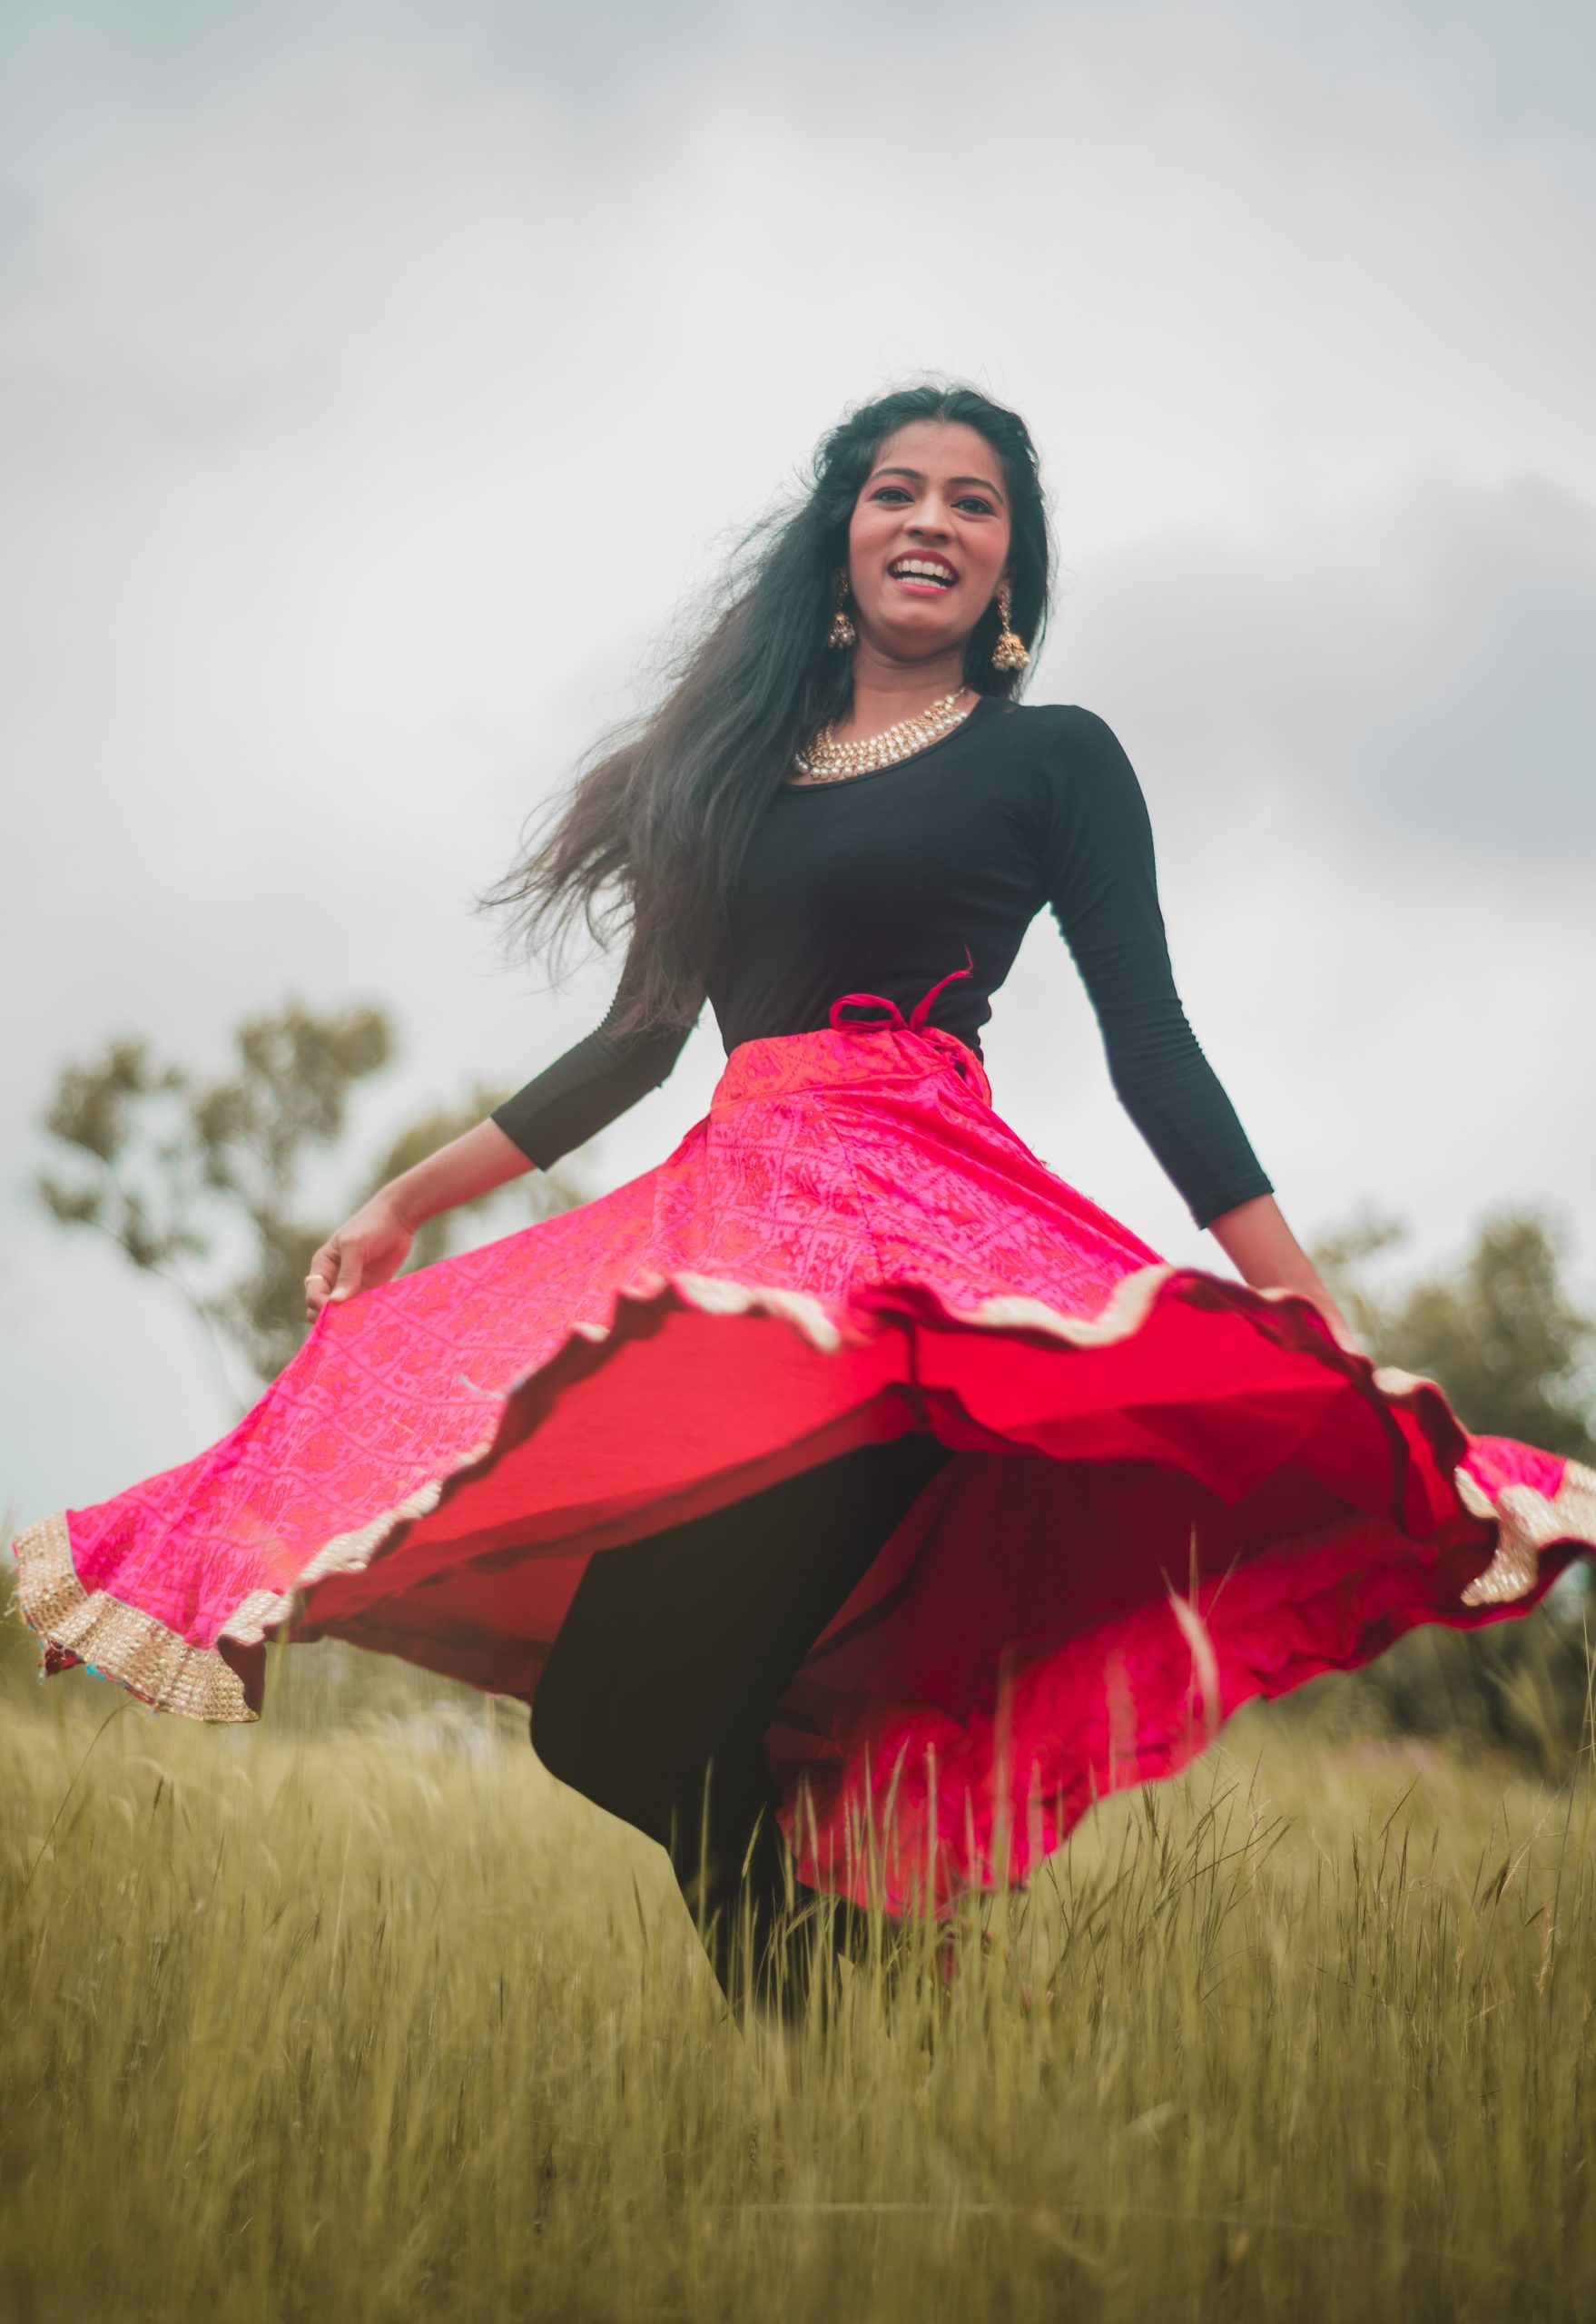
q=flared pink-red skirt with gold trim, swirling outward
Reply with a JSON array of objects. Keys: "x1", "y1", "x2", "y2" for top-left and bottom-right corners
[{"x1": 16, "y1": 1011, "x2": 1596, "y2": 1905}]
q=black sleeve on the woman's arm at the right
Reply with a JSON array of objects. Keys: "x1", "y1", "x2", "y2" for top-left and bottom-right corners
[{"x1": 1046, "y1": 709, "x2": 1273, "y2": 1227}]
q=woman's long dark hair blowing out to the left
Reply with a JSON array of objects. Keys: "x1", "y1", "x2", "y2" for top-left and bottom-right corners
[{"x1": 483, "y1": 383, "x2": 1050, "y2": 1032}]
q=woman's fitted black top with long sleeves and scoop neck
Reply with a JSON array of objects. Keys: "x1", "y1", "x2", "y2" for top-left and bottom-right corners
[{"x1": 492, "y1": 694, "x2": 1273, "y2": 1227}]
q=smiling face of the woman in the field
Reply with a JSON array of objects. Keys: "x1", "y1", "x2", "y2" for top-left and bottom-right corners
[{"x1": 848, "y1": 420, "x2": 1010, "y2": 663}]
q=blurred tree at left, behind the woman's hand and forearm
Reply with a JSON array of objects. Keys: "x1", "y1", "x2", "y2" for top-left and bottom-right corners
[{"x1": 37, "y1": 1001, "x2": 586, "y2": 1394}]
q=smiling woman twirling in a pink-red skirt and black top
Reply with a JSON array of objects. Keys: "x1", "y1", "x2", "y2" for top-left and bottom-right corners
[{"x1": 18, "y1": 386, "x2": 1596, "y2": 1980}]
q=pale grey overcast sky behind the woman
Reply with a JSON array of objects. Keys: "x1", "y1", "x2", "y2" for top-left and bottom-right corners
[{"x1": 0, "y1": 0, "x2": 1596, "y2": 1522}]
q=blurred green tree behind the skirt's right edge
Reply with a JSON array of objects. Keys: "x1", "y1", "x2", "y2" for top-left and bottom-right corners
[{"x1": 1301, "y1": 1211, "x2": 1596, "y2": 1773}]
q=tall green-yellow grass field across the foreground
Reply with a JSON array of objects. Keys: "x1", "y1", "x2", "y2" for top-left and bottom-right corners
[{"x1": 0, "y1": 1650, "x2": 1596, "y2": 2324}]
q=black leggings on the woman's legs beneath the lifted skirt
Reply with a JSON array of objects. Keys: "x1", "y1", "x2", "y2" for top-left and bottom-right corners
[{"x1": 532, "y1": 1436, "x2": 952, "y2": 1984}]
